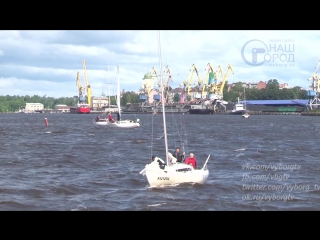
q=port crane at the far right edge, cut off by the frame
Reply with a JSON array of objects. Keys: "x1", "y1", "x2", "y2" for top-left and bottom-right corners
[{"x1": 307, "y1": 60, "x2": 320, "y2": 110}]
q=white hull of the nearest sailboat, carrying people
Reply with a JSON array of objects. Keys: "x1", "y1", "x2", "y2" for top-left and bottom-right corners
[{"x1": 140, "y1": 163, "x2": 209, "y2": 187}]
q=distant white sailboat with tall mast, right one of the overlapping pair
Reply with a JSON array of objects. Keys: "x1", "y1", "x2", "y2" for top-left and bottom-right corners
[{"x1": 108, "y1": 66, "x2": 140, "y2": 128}]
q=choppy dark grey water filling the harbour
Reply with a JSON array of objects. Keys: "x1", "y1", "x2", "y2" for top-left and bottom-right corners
[{"x1": 0, "y1": 113, "x2": 320, "y2": 211}]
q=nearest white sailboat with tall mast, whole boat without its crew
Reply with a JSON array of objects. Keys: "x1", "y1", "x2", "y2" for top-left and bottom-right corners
[{"x1": 139, "y1": 32, "x2": 210, "y2": 187}]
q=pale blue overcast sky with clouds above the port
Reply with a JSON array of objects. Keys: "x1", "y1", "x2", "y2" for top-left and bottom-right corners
[{"x1": 0, "y1": 30, "x2": 320, "y2": 98}]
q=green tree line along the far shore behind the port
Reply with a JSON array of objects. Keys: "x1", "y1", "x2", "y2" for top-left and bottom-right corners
[{"x1": 0, "y1": 79, "x2": 308, "y2": 112}]
